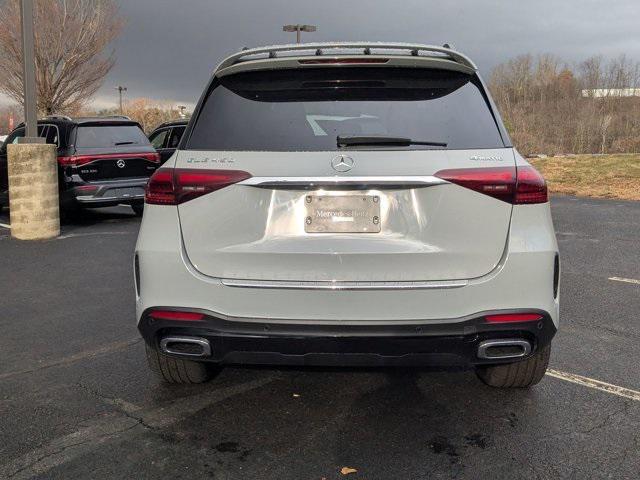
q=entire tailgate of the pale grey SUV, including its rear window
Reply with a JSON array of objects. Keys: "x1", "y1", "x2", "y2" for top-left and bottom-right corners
[{"x1": 170, "y1": 65, "x2": 516, "y2": 286}]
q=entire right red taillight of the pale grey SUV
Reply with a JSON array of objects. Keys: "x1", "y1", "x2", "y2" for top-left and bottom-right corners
[{"x1": 435, "y1": 166, "x2": 548, "y2": 205}]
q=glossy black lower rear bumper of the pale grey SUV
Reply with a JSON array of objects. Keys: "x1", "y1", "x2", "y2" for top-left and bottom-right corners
[{"x1": 138, "y1": 308, "x2": 556, "y2": 368}]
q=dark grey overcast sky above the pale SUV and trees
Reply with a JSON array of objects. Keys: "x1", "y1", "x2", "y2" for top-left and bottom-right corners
[{"x1": 90, "y1": 0, "x2": 640, "y2": 106}]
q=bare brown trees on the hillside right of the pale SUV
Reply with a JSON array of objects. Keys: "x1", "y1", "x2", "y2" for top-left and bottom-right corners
[{"x1": 489, "y1": 55, "x2": 640, "y2": 154}]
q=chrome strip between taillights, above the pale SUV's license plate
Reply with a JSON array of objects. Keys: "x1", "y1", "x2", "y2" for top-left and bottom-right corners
[{"x1": 236, "y1": 175, "x2": 449, "y2": 189}]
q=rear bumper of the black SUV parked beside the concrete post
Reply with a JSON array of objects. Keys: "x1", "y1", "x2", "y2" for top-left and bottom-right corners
[{"x1": 68, "y1": 177, "x2": 148, "y2": 208}]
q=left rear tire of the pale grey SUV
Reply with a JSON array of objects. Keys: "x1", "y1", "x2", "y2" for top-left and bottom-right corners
[{"x1": 145, "y1": 344, "x2": 220, "y2": 384}]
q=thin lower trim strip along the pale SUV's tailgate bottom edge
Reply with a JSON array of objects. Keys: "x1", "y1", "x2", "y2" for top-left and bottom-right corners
[{"x1": 220, "y1": 278, "x2": 469, "y2": 290}]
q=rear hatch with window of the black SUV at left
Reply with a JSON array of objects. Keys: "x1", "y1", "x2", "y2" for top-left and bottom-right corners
[{"x1": 67, "y1": 121, "x2": 159, "y2": 182}]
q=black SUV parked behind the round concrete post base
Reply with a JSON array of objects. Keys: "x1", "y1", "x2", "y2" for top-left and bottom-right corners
[{"x1": 0, "y1": 116, "x2": 160, "y2": 215}]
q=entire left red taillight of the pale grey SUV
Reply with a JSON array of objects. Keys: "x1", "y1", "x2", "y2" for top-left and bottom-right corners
[{"x1": 145, "y1": 168, "x2": 251, "y2": 205}]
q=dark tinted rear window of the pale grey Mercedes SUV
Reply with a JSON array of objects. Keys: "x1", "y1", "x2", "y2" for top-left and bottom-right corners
[{"x1": 187, "y1": 67, "x2": 504, "y2": 151}]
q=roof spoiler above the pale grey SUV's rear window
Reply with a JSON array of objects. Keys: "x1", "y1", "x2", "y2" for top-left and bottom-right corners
[{"x1": 216, "y1": 42, "x2": 477, "y2": 71}]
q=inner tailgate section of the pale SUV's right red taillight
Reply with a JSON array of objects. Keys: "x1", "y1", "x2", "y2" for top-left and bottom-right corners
[{"x1": 435, "y1": 167, "x2": 516, "y2": 203}]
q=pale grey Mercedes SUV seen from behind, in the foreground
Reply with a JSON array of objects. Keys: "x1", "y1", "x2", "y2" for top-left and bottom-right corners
[{"x1": 134, "y1": 43, "x2": 559, "y2": 387}]
